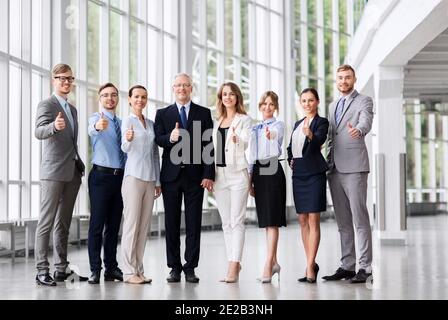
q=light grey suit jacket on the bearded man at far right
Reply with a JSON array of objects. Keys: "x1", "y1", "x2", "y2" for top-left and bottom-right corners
[{"x1": 327, "y1": 90, "x2": 373, "y2": 173}]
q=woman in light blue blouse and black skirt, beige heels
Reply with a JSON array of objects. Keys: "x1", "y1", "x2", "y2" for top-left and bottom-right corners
[{"x1": 249, "y1": 91, "x2": 286, "y2": 283}]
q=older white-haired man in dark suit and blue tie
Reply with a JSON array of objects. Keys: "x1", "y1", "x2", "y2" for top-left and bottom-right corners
[{"x1": 155, "y1": 74, "x2": 215, "y2": 283}]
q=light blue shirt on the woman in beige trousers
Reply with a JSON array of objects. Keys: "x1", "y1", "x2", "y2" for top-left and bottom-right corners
[{"x1": 121, "y1": 113, "x2": 161, "y2": 186}]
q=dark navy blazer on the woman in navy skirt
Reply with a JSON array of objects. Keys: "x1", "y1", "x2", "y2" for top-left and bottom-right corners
[{"x1": 288, "y1": 115, "x2": 329, "y2": 177}]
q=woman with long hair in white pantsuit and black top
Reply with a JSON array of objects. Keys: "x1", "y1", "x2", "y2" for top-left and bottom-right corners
[{"x1": 213, "y1": 82, "x2": 252, "y2": 283}]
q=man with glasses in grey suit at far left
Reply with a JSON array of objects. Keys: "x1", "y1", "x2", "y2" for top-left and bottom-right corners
[{"x1": 34, "y1": 64, "x2": 88, "y2": 286}]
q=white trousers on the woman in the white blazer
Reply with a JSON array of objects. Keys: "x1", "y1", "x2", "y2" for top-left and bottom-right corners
[{"x1": 214, "y1": 167, "x2": 249, "y2": 262}]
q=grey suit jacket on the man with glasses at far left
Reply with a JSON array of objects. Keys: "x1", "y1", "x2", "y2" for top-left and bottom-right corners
[{"x1": 34, "y1": 95, "x2": 84, "y2": 182}]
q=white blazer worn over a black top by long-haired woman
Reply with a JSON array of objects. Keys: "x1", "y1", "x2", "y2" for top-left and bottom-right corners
[{"x1": 213, "y1": 113, "x2": 252, "y2": 171}]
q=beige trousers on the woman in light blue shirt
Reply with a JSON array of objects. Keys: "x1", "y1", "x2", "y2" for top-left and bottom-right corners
[{"x1": 121, "y1": 176, "x2": 155, "y2": 280}]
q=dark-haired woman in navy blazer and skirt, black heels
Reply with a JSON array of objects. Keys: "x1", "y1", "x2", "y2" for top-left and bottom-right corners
[{"x1": 288, "y1": 88, "x2": 329, "y2": 283}]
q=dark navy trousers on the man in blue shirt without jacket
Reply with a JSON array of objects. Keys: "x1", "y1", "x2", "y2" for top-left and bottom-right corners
[{"x1": 88, "y1": 169, "x2": 123, "y2": 272}]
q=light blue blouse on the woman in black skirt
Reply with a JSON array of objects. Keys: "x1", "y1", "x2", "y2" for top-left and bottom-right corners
[{"x1": 249, "y1": 118, "x2": 285, "y2": 173}]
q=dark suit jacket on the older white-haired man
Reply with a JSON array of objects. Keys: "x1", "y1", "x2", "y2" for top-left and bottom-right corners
[{"x1": 154, "y1": 102, "x2": 215, "y2": 183}]
